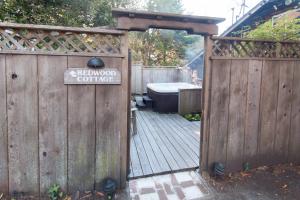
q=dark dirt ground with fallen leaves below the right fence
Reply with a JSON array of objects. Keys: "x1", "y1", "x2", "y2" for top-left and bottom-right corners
[{"x1": 204, "y1": 164, "x2": 300, "y2": 200}]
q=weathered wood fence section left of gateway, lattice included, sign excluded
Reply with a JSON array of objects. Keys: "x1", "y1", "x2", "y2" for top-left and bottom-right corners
[{"x1": 0, "y1": 24, "x2": 128, "y2": 195}]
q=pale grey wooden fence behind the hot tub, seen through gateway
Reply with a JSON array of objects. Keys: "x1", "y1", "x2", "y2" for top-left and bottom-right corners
[{"x1": 131, "y1": 65, "x2": 192, "y2": 94}]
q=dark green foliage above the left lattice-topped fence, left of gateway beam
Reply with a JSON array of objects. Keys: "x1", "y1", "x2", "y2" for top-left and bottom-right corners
[{"x1": 0, "y1": 0, "x2": 135, "y2": 26}]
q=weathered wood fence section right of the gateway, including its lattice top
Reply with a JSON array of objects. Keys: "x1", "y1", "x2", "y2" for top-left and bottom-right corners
[{"x1": 201, "y1": 38, "x2": 300, "y2": 171}]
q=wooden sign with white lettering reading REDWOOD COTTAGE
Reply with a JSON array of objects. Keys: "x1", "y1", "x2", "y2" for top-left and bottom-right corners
[{"x1": 64, "y1": 68, "x2": 121, "y2": 85}]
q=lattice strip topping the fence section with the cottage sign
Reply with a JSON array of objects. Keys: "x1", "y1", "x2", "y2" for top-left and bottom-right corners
[{"x1": 0, "y1": 27, "x2": 121, "y2": 54}]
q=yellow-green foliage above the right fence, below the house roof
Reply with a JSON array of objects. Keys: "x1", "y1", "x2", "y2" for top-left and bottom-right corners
[{"x1": 246, "y1": 11, "x2": 300, "y2": 41}]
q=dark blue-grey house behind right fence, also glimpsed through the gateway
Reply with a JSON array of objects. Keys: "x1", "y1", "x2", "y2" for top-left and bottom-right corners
[{"x1": 184, "y1": 0, "x2": 300, "y2": 82}]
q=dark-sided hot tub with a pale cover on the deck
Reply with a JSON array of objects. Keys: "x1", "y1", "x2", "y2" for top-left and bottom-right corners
[{"x1": 147, "y1": 82, "x2": 200, "y2": 113}]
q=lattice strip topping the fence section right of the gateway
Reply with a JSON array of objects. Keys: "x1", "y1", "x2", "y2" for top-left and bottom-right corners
[{"x1": 212, "y1": 38, "x2": 300, "y2": 59}]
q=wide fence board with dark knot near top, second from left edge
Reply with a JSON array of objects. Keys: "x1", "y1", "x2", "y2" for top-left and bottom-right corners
[{"x1": 6, "y1": 55, "x2": 39, "y2": 194}]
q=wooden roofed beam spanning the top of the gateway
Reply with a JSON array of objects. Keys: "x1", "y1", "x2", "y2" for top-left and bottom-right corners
[{"x1": 112, "y1": 9, "x2": 224, "y2": 35}]
